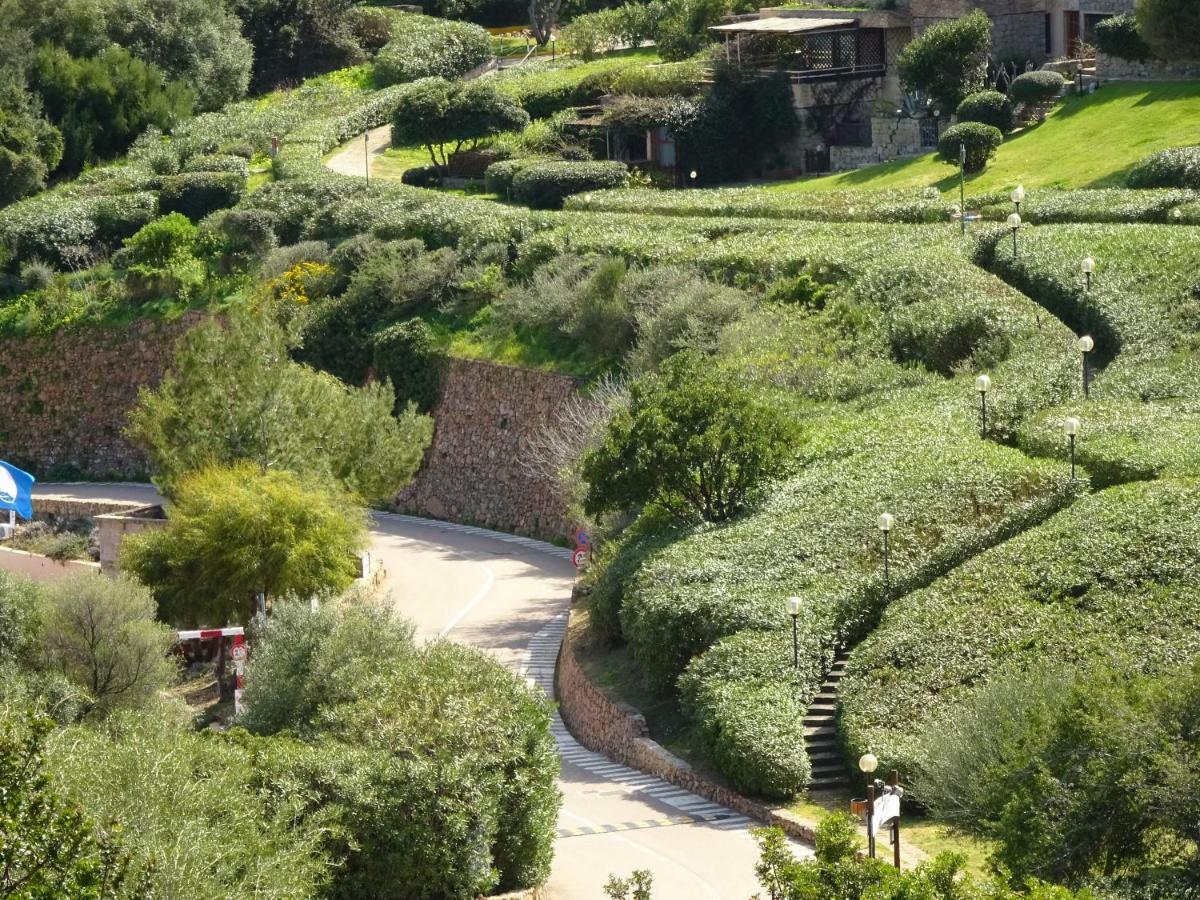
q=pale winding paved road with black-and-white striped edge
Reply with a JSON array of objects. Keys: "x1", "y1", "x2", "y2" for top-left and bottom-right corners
[{"x1": 35, "y1": 484, "x2": 808, "y2": 900}]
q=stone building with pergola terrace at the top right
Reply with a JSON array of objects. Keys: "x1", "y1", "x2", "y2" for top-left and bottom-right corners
[{"x1": 712, "y1": 0, "x2": 1134, "y2": 172}]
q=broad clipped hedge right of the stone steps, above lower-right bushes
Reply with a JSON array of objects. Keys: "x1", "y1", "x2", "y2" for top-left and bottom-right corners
[{"x1": 841, "y1": 480, "x2": 1200, "y2": 799}]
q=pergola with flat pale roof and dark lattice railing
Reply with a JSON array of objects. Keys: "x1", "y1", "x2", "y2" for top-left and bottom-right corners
[{"x1": 709, "y1": 16, "x2": 884, "y2": 80}]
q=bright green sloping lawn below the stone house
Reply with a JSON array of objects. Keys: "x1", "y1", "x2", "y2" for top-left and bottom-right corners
[{"x1": 772, "y1": 82, "x2": 1200, "y2": 194}]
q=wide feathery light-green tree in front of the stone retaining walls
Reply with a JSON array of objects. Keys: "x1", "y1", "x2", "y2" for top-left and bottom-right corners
[{"x1": 128, "y1": 304, "x2": 433, "y2": 500}]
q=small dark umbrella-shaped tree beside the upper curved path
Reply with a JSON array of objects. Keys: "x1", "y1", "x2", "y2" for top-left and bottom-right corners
[{"x1": 391, "y1": 78, "x2": 529, "y2": 174}]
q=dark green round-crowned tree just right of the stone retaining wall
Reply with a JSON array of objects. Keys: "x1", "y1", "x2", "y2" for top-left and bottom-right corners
[{"x1": 583, "y1": 350, "x2": 797, "y2": 522}]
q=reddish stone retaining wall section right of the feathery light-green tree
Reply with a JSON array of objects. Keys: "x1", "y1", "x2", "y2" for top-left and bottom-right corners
[{"x1": 396, "y1": 360, "x2": 578, "y2": 539}]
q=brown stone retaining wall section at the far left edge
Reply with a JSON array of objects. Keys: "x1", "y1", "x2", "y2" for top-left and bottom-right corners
[{"x1": 0, "y1": 313, "x2": 203, "y2": 481}]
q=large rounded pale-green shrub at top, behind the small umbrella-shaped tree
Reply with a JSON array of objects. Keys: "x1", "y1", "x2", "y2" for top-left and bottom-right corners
[{"x1": 374, "y1": 14, "x2": 492, "y2": 85}]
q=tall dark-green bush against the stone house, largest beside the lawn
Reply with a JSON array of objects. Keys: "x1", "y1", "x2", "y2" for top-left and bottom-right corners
[{"x1": 898, "y1": 10, "x2": 991, "y2": 112}]
